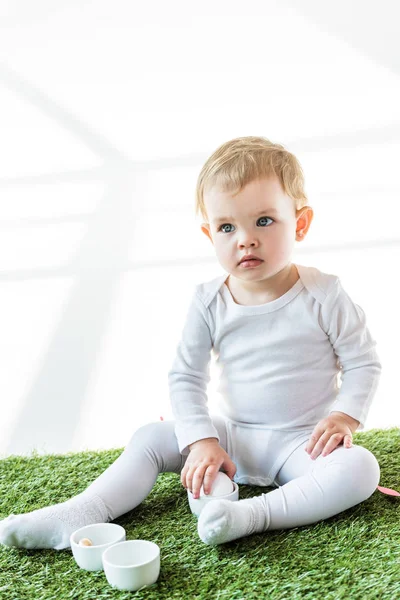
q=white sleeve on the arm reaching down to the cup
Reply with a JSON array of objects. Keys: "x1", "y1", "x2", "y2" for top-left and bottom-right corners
[{"x1": 168, "y1": 292, "x2": 219, "y2": 454}]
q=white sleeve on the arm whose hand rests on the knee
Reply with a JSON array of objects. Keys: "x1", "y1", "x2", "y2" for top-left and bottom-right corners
[{"x1": 320, "y1": 280, "x2": 381, "y2": 429}]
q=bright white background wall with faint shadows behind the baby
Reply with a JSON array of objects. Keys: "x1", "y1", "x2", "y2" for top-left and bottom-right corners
[{"x1": 0, "y1": 0, "x2": 400, "y2": 455}]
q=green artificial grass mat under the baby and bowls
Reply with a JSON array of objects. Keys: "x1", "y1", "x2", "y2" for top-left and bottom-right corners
[{"x1": 0, "y1": 428, "x2": 400, "y2": 600}]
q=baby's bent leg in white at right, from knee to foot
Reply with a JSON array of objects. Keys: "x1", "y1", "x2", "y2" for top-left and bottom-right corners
[{"x1": 198, "y1": 442, "x2": 379, "y2": 545}]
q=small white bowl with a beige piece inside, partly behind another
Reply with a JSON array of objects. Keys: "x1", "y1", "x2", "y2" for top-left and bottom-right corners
[{"x1": 70, "y1": 523, "x2": 126, "y2": 571}]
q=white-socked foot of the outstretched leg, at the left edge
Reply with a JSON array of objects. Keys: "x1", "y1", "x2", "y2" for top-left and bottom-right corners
[{"x1": 0, "y1": 494, "x2": 110, "y2": 550}]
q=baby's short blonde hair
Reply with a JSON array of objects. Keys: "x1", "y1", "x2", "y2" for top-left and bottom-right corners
[{"x1": 196, "y1": 136, "x2": 308, "y2": 221}]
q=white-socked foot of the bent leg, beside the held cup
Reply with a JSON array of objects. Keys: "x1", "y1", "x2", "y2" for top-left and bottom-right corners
[{"x1": 197, "y1": 498, "x2": 269, "y2": 546}]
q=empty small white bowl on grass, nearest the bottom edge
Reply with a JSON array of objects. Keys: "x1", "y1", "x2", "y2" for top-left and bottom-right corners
[{"x1": 103, "y1": 540, "x2": 160, "y2": 592}]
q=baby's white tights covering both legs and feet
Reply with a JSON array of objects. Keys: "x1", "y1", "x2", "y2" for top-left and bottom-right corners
[{"x1": 0, "y1": 417, "x2": 379, "y2": 550}]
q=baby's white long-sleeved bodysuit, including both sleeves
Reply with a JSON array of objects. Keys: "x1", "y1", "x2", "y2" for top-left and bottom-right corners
[{"x1": 169, "y1": 265, "x2": 381, "y2": 485}]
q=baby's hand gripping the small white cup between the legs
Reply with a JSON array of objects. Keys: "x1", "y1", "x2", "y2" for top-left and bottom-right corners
[{"x1": 181, "y1": 438, "x2": 236, "y2": 498}]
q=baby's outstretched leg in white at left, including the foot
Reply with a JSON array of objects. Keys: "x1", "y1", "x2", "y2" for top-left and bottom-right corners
[{"x1": 0, "y1": 420, "x2": 223, "y2": 550}]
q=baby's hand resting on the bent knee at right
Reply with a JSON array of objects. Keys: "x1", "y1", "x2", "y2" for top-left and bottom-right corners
[{"x1": 306, "y1": 412, "x2": 359, "y2": 459}]
